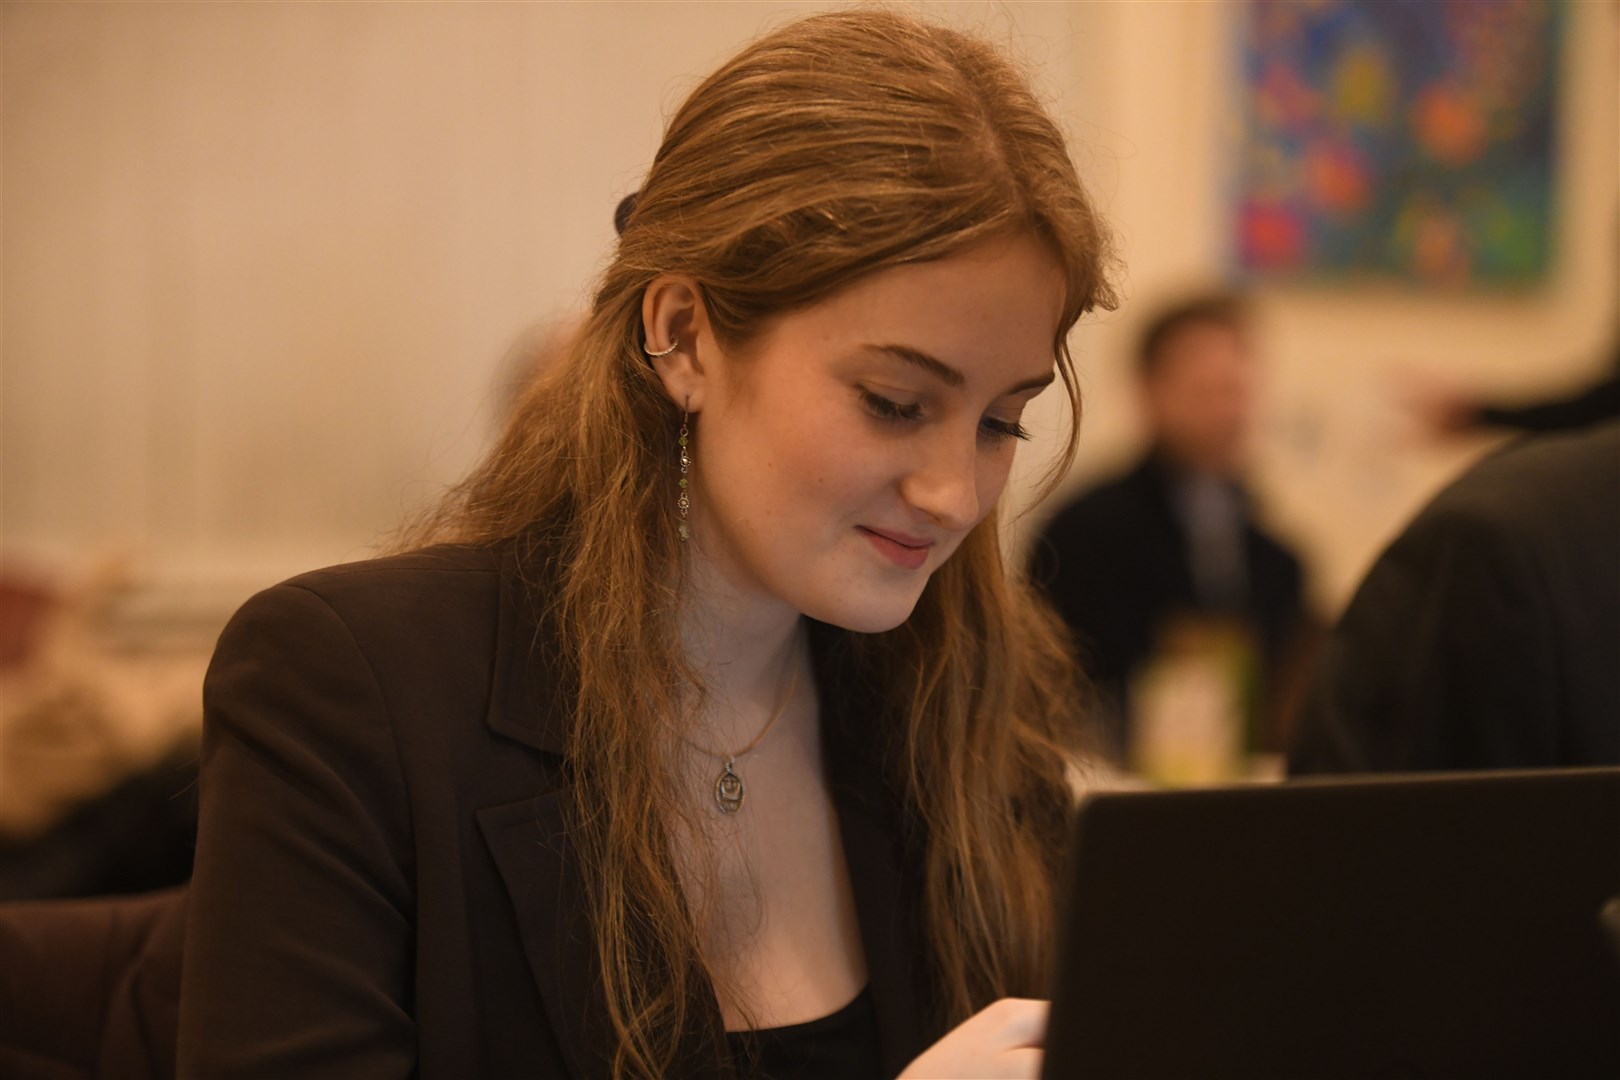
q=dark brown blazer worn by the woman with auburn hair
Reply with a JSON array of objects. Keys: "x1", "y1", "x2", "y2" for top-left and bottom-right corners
[{"x1": 180, "y1": 547, "x2": 940, "y2": 1080}]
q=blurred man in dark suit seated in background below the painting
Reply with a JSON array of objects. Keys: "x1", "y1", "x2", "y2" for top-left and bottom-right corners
[{"x1": 1030, "y1": 295, "x2": 1307, "y2": 758}]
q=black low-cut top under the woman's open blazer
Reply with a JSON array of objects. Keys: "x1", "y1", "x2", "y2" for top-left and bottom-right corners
[{"x1": 726, "y1": 988, "x2": 883, "y2": 1080}]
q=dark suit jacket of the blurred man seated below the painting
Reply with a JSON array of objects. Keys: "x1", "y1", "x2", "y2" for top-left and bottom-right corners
[{"x1": 1030, "y1": 453, "x2": 1304, "y2": 748}]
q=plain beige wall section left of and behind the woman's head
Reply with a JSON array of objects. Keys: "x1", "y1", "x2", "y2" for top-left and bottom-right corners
[{"x1": 0, "y1": 3, "x2": 1072, "y2": 608}]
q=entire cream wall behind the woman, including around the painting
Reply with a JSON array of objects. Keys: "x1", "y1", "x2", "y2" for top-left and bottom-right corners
[{"x1": 0, "y1": 0, "x2": 1620, "y2": 621}]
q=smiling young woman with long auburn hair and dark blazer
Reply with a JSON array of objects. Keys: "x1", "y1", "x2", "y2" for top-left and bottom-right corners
[{"x1": 180, "y1": 11, "x2": 1111, "y2": 1077}]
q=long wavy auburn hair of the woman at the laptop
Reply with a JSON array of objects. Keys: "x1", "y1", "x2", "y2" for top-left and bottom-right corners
[{"x1": 405, "y1": 10, "x2": 1115, "y2": 1077}]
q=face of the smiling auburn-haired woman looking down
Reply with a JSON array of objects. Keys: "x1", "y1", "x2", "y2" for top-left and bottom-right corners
[{"x1": 692, "y1": 229, "x2": 1064, "y2": 631}]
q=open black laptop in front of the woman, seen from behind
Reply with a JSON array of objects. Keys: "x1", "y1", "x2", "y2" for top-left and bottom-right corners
[{"x1": 1043, "y1": 767, "x2": 1620, "y2": 1080}]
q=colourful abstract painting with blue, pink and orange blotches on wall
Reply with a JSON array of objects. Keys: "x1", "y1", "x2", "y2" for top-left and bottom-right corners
[{"x1": 1234, "y1": 0, "x2": 1562, "y2": 287}]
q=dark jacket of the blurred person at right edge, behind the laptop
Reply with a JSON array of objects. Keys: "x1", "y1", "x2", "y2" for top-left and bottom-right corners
[{"x1": 1290, "y1": 423, "x2": 1620, "y2": 774}]
